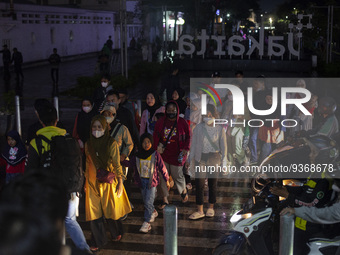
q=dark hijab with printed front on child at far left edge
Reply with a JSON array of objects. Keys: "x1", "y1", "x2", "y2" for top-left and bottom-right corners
[{"x1": 1, "y1": 130, "x2": 27, "y2": 166}]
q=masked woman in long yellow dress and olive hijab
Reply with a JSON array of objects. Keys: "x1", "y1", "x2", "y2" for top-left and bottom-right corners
[{"x1": 85, "y1": 115, "x2": 131, "y2": 252}]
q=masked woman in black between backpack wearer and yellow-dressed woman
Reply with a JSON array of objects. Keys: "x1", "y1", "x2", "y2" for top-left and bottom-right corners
[{"x1": 72, "y1": 97, "x2": 96, "y2": 152}]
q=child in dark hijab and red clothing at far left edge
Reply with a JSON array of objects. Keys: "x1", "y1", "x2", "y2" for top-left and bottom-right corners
[{"x1": 0, "y1": 130, "x2": 27, "y2": 184}]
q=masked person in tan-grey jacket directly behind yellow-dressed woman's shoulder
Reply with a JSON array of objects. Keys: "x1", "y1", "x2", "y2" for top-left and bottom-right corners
[{"x1": 101, "y1": 105, "x2": 133, "y2": 172}]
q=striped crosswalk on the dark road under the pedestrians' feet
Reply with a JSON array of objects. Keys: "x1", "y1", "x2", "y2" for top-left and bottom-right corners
[{"x1": 78, "y1": 179, "x2": 250, "y2": 255}]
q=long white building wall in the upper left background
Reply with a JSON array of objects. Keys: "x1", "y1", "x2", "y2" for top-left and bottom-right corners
[{"x1": 0, "y1": 1, "x2": 142, "y2": 66}]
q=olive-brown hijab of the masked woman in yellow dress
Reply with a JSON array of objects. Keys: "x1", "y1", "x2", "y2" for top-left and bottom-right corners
[{"x1": 88, "y1": 115, "x2": 115, "y2": 169}]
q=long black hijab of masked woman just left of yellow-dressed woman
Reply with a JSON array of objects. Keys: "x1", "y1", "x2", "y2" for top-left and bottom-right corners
[{"x1": 77, "y1": 97, "x2": 96, "y2": 143}]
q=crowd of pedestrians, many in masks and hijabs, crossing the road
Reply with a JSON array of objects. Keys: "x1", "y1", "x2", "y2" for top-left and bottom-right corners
[{"x1": 0, "y1": 70, "x2": 340, "y2": 254}]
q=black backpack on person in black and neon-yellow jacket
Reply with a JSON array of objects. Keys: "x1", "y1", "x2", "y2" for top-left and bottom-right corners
[{"x1": 36, "y1": 134, "x2": 84, "y2": 193}]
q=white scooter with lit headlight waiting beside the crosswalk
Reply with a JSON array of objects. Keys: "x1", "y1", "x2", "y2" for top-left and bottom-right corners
[{"x1": 213, "y1": 180, "x2": 340, "y2": 255}]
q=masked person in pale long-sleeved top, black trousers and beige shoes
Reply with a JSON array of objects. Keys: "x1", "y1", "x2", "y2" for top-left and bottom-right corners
[{"x1": 186, "y1": 104, "x2": 227, "y2": 220}]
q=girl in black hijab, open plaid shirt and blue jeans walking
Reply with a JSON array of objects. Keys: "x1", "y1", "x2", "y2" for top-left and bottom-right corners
[{"x1": 134, "y1": 133, "x2": 170, "y2": 233}]
